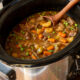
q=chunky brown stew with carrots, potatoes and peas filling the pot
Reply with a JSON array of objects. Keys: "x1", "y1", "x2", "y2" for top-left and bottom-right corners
[{"x1": 5, "y1": 11, "x2": 77, "y2": 60}]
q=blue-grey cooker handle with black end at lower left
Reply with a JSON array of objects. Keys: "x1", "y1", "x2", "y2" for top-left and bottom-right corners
[{"x1": 0, "y1": 62, "x2": 16, "y2": 80}]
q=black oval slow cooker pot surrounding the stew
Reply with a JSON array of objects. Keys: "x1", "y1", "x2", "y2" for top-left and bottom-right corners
[{"x1": 0, "y1": 0, "x2": 80, "y2": 78}]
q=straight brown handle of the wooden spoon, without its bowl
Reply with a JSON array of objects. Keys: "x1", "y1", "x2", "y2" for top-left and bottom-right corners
[{"x1": 54, "y1": 0, "x2": 80, "y2": 21}]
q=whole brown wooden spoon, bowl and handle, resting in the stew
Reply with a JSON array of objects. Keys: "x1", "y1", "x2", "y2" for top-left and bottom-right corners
[{"x1": 43, "y1": 0, "x2": 80, "y2": 26}]
